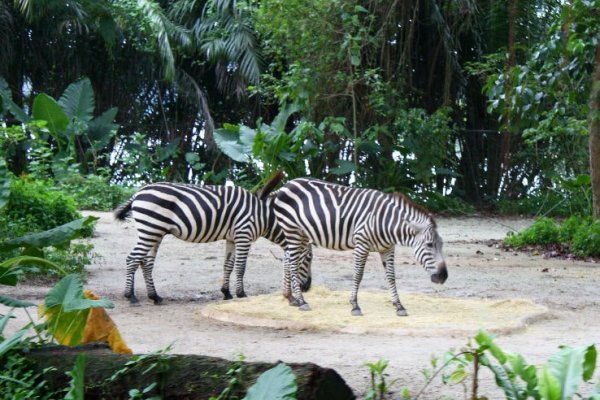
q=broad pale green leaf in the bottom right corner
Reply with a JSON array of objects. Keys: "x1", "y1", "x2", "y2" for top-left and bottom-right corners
[{"x1": 548, "y1": 346, "x2": 595, "y2": 399}]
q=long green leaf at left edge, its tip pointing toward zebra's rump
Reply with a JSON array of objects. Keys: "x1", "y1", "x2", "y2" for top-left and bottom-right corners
[{"x1": 0, "y1": 216, "x2": 98, "y2": 251}]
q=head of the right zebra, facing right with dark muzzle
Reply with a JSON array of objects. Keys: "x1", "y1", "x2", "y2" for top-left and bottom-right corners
[{"x1": 410, "y1": 221, "x2": 448, "y2": 284}]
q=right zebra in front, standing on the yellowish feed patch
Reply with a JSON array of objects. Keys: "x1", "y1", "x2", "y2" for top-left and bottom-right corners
[{"x1": 275, "y1": 178, "x2": 448, "y2": 316}]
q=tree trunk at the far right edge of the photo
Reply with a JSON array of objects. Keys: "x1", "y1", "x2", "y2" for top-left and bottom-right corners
[{"x1": 589, "y1": 43, "x2": 600, "y2": 219}]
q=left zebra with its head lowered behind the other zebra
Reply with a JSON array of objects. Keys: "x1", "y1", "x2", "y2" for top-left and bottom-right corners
[{"x1": 114, "y1": 174, "x2": 312, "y2": 304}]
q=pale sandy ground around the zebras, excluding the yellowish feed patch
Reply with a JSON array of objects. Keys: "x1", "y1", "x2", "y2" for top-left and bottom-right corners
[{"x1": 0, "y1": 213, "x2": 600, "y2": 399}]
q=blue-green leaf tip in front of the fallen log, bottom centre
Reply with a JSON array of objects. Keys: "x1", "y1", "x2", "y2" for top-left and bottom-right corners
[{"x1": 244, "y1": 363, "x2": 298, "y2": 400}]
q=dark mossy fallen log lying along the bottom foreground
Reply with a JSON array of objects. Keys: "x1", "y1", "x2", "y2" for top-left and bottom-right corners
[{"x1": 25, "y1": 344, "x2": 355, "y2": 400}]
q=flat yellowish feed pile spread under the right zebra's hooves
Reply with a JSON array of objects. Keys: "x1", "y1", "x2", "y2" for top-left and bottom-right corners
[{"x1": 201, "y1": 287, "x2": 548, "y2": 336}]
